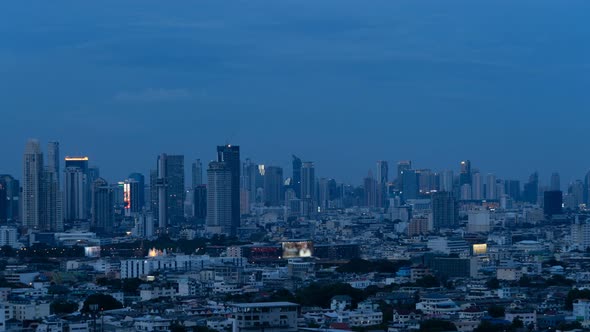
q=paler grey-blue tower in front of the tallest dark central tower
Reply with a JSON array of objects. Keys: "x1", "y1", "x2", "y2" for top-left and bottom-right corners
[{"x1": 207, "y1": 161, "x2": 232, "y2": 235}]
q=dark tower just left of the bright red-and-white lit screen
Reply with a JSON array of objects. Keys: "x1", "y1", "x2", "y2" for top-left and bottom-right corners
[{"x1": 91, "y1": 178, "x2": 115, "y2": 232}]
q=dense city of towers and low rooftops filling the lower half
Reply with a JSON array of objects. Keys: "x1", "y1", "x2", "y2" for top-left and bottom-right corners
[{"x1": 0, "y1": 140, "x2": 590, "y2": 332}]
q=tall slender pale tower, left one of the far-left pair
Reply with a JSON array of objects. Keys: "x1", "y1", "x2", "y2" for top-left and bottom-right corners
[{"x1": 22, "y1": 140, "x2": 43, "y2": 229}]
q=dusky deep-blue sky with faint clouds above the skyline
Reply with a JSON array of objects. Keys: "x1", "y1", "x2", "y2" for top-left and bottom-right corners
[{"x1": 0, "y1": 0, "x2": 590, "y2": 184}]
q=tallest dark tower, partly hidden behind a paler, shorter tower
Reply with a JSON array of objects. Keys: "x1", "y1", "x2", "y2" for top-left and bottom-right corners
[{"x1": 217, "y1": 144, "x2": 242, "y2": 236}]
